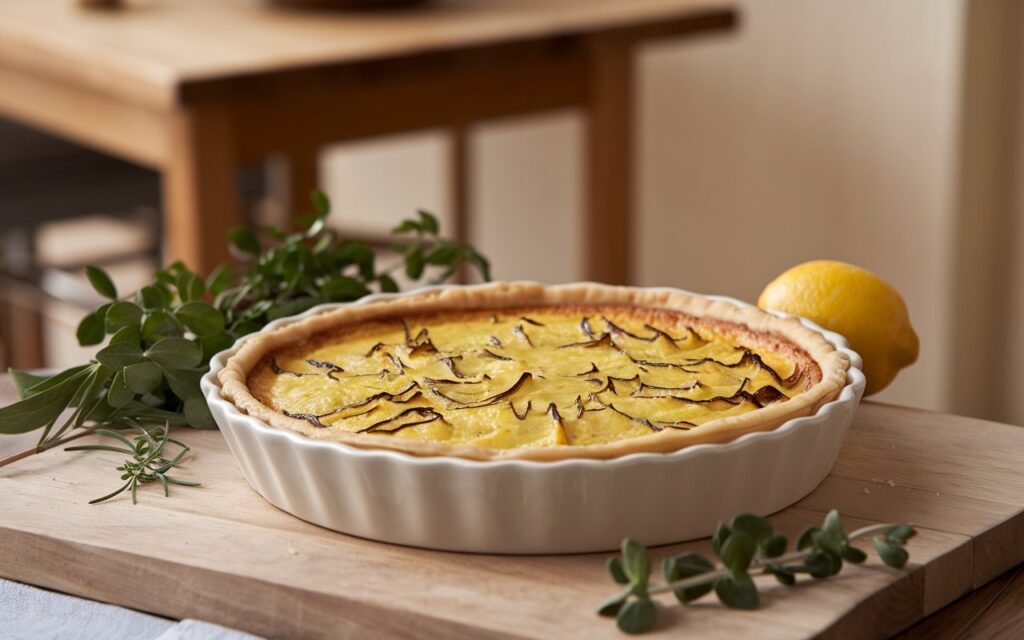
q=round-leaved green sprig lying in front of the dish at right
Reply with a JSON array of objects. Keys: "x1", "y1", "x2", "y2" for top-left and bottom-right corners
[{"x1": 597, "y1": 509, "x2": 916, "y2": 634}]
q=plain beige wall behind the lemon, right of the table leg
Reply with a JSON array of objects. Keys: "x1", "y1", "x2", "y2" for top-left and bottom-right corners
[{"x1": 637, "y1": 0, "x2": 961, "y2": 409}]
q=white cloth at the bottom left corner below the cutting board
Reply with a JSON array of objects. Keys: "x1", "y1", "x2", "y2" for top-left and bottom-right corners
[{"x1": 0, "y1": 580, "x2": 257, "y2": 640}]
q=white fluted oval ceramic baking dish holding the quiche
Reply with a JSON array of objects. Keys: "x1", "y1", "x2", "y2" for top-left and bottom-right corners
[{"x1": 202, "y1": 282, "x2": 864, "y2": 554}]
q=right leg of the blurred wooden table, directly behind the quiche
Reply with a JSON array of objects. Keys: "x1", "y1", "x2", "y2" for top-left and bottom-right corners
[{"x1": 583, "y1": 35, "x2": 633, "y2": 285}]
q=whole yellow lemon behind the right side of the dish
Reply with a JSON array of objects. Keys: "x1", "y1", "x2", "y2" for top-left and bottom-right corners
[{"x1": 758, "y1": 260, "x2": 919, "y2": 395}]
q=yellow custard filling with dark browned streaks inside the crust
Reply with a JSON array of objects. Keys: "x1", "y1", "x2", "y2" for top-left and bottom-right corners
[{"x1": 248, "y1": 305, "x2": 820, "y2": 449}]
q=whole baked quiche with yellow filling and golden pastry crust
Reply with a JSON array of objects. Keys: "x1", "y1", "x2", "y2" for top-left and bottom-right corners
[{"x1": 219, "y1": 283, "x2": 850, "y2": 461}]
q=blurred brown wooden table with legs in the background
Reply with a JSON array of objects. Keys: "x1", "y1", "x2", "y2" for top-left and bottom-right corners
[{"x1": 0, "y1": 0, "x2": 734, "y2": 283}]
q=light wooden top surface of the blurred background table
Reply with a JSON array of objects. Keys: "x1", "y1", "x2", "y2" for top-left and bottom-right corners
[{"x1": 0, "y1": 0, "x2": 735, "y2": 103}]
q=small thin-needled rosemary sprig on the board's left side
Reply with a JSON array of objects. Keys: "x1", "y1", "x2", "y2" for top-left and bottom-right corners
[{"x1": 65, "y1": 425, "x2": 201, "y2": 505}]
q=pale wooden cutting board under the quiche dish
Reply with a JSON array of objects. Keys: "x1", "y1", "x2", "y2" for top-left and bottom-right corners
[{"x1": 0, "y1": 380, "x2": 1024, "y2": 638}]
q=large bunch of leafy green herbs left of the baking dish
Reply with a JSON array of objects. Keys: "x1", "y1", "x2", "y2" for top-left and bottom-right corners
[{"x1": 0, "y1": 191, "x2": 490, "y2": 498}]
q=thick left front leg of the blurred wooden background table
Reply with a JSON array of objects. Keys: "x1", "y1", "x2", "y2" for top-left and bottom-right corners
[{"x1": 164, "y1": 106, "x2": 244, "y2": 273}]
